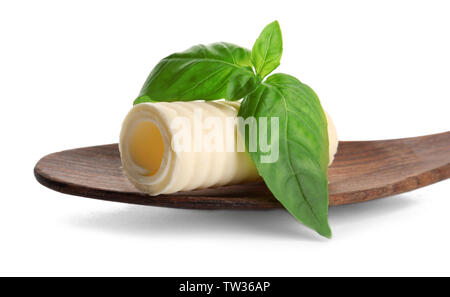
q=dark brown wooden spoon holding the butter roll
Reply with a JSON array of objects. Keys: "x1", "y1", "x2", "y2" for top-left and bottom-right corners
[{"x1": 34, "y1": 132, "x2": 450, "y2": 209}]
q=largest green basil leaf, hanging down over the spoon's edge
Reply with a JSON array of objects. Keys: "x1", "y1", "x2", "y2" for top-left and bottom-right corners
[{"x1": 239, "y1": 74, "x2": 331, "y2": 237}]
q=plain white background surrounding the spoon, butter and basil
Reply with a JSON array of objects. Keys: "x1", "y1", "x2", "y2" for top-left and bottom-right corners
[{"x1": 0, "y1": 0, "x2": 450, "y2": 276}]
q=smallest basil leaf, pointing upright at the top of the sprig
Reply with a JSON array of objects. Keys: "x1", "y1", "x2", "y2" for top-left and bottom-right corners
[{"x1": 252, "y1": 21, "x2": 283, "y2": 78}]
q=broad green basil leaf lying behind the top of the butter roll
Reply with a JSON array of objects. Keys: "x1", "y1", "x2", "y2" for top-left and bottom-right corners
[{"x1": 138, "y1": 42, "x2": 256, "y2": 103}]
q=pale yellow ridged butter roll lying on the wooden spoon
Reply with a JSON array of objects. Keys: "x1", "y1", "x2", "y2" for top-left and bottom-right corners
[{"x1": 119, "y1": 101, "x2": 338, "y2": 195}]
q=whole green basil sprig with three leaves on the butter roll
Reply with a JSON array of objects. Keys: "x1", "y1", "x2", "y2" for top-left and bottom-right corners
[{"x1": 134, "y1": 21, "x2": 331, "y2": 237}]
